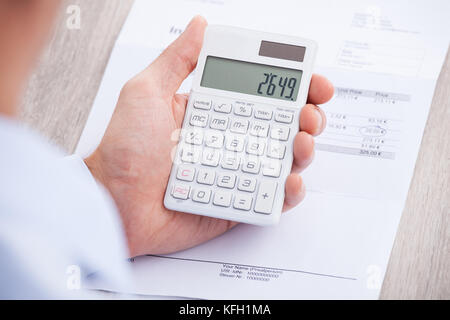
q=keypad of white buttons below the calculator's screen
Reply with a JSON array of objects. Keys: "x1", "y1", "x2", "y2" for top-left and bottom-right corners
[{"x1": 171, "y1": 94, "x2": 294, "y2": 215}]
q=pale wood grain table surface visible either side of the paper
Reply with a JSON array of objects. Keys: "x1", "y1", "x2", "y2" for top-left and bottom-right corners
[{"x1": 21, "y1": 0, "x2": 450, "y2": 299}]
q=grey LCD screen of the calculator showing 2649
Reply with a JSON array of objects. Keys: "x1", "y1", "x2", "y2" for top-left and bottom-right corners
[{"x1": 200, "y1": 56, "x2": 303, "y2": 101}]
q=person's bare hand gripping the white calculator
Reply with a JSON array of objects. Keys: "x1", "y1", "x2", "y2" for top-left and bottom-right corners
[{"x1": 85, "y1": 17, "x2": 334, "y2": 257}]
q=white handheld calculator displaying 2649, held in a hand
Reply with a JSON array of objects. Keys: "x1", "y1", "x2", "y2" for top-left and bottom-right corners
[{"x1": 164, "y1": 26, "x2": 317, "y2": 226}]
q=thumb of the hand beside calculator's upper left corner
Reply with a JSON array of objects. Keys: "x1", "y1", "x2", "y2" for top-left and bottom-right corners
[{"x1": 144, "y1": 16, "x2": 207, "y2": 96}]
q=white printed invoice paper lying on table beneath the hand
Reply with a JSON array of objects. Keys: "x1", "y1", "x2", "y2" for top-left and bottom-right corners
[{"x1": 77, "y1": 0, "x2": 450, "y2": 299}]
